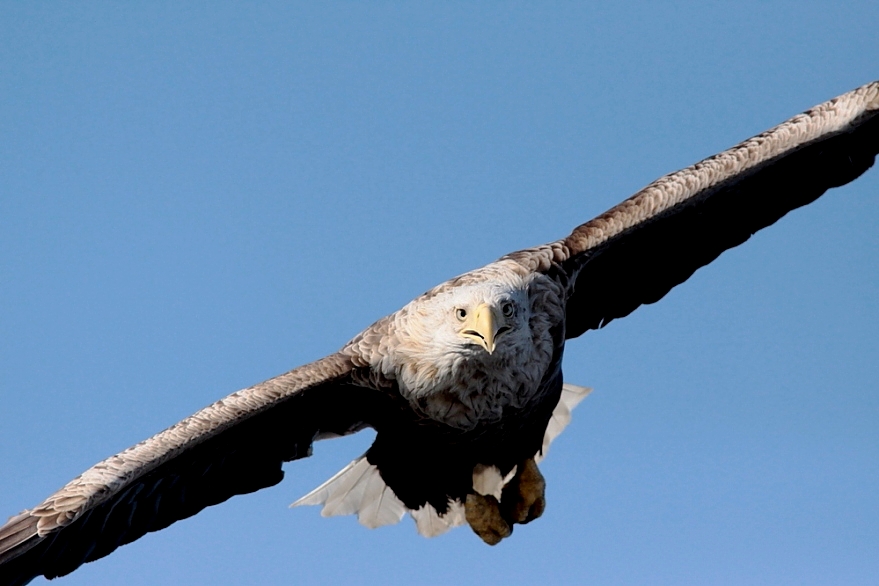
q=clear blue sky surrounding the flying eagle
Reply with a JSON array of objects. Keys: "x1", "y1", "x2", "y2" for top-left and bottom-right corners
[{"x1": 0, "y1": 1, "x2": 879, "y2": 586}]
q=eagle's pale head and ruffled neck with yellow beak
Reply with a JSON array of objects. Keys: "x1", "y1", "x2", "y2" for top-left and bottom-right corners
[{"x1": 378, "y1": 263, "x2": 563, "y2": 427}]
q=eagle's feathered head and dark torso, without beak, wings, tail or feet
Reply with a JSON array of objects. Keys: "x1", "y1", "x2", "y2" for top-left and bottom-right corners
[{"x1": 341, "y1": 259, "x2": 565, "y2": 514}]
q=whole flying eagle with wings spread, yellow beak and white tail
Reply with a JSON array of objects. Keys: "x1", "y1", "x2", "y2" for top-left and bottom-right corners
[{"x1": 0, "y1": 81, "x2": 879, "y2": 585}]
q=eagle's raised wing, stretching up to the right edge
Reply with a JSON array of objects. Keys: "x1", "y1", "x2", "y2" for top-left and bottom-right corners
[{"x1": 507, "y1": 81, "x2": 879, "y2": 338}]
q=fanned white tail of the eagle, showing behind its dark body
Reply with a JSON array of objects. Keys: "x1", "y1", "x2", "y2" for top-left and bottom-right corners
[{"x1": 290, "y1": 383, "x2": 592, "y2": 537}]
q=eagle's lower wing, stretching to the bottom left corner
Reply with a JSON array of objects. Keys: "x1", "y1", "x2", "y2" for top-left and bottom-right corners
[{"x1": 0, "y1": 354, "x2": 390, "y2": 585}]
